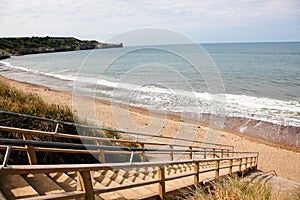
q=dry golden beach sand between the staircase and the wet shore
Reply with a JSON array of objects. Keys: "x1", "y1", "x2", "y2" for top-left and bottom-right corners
[{"x1": 0, "y1": 76, "x2": 300, "y2": 183}]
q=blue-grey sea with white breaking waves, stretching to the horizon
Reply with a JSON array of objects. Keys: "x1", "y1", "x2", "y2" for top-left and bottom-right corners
[{"x1": 0, "y1": 42, "x2": 300, "y2": 127}]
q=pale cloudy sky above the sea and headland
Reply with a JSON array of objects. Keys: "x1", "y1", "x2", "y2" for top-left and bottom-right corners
[{"x1": 0, "y1": 0, "x2": 300, "y2": 43}]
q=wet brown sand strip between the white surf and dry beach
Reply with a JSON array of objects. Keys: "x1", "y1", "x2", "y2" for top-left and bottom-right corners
[{"x1": 0, "y1": 75, "x2": 300, "y2": 152}]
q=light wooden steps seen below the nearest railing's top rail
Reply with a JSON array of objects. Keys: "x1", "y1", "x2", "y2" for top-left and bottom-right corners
[{"x1": 0, "y1": 161, "x2": 254, "y2": 199}]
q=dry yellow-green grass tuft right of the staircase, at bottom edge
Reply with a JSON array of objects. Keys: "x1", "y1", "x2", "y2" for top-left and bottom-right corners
[{"x1": 185, "y1": 177, "x2": 300, "y2": 200}]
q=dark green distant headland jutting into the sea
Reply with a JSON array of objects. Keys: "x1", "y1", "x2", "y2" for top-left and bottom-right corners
[{"x1": 0, "y1": 36, "x2": 123, "y2": 60}]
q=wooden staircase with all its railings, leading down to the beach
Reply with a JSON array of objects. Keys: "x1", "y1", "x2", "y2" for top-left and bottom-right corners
[{"x1": 0, "y1": 112, "x2": 258, "y2": 200}]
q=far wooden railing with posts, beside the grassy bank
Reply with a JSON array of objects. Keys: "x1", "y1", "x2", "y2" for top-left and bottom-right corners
[{"x1": 0, "y1": 126, "x2": 233, "y2": 164}]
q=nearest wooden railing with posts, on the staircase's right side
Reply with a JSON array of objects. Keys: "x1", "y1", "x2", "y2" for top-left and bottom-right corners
[{"x1": 0, "y1": 155, "x2": 258, "y2": 199}]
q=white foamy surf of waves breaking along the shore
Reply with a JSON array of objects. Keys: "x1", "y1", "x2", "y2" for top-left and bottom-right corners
[{"x1": 0, "y1": 61, "x2": 300, "y2": 126}]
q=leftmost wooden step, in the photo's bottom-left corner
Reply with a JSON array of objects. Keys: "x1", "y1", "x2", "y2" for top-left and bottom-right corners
[{"x1": 0, "y1": 175, "x2": 39, "y2": 199}]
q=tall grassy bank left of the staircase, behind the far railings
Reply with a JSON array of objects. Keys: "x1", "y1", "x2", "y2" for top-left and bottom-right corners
[{"x1": 0, "y1": 82, "x2": 139, "y2": 164}]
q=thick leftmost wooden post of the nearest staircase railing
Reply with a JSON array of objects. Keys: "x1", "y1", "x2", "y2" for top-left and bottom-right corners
[{"x1": 79, "y1": 171, "x2": 95, "y2": 200}]
